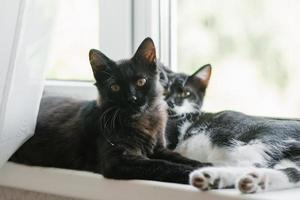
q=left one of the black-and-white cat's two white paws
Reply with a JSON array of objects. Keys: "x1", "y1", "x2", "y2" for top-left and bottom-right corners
[{"x1": 190, "y1": 167, "x2": 229, "y2": 191}]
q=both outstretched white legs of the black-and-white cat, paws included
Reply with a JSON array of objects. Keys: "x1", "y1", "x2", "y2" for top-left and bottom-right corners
[{"x1": 190, "y1": 167, "x2": 300, "y2": 193}]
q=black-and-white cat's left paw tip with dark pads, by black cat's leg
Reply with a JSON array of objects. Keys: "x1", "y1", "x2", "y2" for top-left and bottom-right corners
[{"x1": 190, "y1": 169, "x2": 220, "y2": 191}]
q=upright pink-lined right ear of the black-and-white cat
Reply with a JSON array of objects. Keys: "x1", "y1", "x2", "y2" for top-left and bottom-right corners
[{"x1": 187, "y1": 64, "x2": 211, "y2": 90}]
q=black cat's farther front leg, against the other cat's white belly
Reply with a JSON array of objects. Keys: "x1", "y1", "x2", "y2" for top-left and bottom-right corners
[{"x1": 150, "y1": 147, "x2": 212, "y2": 169}]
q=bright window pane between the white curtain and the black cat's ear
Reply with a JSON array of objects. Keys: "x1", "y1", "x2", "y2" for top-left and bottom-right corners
[{"x1": 47, "y1": 0, "x2": 99, "y2": 80}]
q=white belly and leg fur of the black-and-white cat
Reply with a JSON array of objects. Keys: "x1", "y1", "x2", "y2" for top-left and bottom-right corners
[{"x1": 185, "y1": 132, "x2": 300, "y2": 193}]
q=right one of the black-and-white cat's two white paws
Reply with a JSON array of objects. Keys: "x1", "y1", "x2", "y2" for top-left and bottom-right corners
[{"x1": 236, "y1": 172, "x2": 268, "y2": 193}]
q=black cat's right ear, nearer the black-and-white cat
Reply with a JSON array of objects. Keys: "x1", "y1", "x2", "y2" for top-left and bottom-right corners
[{"x1": 133, "y1": 37, "x2": 156, "y2": 64}]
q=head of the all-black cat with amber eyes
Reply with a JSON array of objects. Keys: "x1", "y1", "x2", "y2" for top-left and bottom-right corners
[{"x1": 89, "y1": 38, "x2": 162, "y2": 113}]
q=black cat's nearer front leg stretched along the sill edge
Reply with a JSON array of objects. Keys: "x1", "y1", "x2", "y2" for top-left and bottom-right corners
[{"x1": 100, "y1": 149, "x2": 193, "y2": 184}]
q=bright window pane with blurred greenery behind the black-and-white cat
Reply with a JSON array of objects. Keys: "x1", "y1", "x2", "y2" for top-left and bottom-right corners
[{"x1": 177, "y1": 0, "x2": 300, "y2": 117}]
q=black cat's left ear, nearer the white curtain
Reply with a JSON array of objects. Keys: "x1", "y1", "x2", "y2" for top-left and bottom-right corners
[{"x1": 89, "y1": 49, "x2": 113, "y2": 74}]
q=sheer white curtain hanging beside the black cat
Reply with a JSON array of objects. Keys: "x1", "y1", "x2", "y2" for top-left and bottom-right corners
[{"x1": 0, "y1": 0, "x2": 57, "y2": 167}]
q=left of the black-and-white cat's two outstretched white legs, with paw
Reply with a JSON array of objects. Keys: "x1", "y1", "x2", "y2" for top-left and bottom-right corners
[{"x1": 190, "y1": 167, "x2": 252, "y2": 191}]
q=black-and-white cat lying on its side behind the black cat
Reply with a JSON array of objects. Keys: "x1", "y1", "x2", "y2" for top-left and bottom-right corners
[{"x1": 164, "y1": 65, "x2": 300, "y2": 193}]
